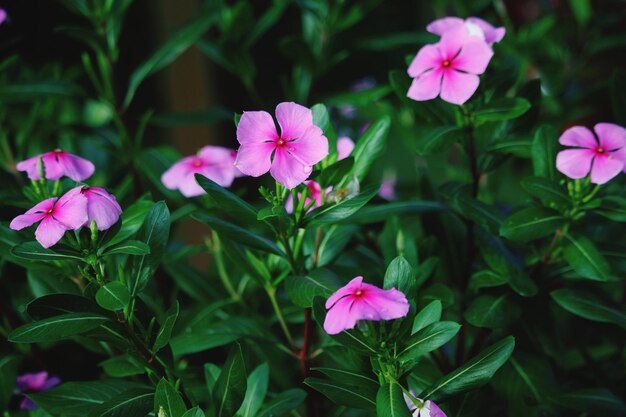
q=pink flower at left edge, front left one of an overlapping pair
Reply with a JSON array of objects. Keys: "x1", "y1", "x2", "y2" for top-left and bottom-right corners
[{"x1": 9, "y1": 193, "x2": 88, "y2": 248}]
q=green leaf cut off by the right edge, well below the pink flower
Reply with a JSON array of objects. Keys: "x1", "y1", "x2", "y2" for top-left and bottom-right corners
[{"x1": 550, "y1": 288, "x2": 626, "y2": 329}]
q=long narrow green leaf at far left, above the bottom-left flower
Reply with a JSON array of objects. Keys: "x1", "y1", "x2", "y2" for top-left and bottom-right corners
[{"x1": 8, "y1": 313, "x2": 108, "y2": 343}]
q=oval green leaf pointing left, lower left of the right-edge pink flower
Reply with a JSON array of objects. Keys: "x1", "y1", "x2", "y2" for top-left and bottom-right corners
[{"x1": 500, "y1": 207, "x2": 567, "y2": 242}]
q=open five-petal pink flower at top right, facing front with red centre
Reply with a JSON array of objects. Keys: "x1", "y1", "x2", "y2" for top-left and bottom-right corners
[{"x1": 407, "y1": 28, "x2": 493, "y2": 104}]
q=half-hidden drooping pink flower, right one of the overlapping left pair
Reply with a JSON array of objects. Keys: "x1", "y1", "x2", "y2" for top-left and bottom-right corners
[{"x1": 65, "y1": 185, "x2": 122, "y2": 230}]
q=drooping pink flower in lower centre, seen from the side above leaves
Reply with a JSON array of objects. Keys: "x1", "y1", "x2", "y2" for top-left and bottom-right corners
[{"x1": 324, "y1": 277, "x2": 409, "y2": 334}]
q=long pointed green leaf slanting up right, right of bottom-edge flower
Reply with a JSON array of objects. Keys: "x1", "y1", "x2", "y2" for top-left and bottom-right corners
[{"x1": 421, "y1": 336, "x2": 515, "y2": 401}]
